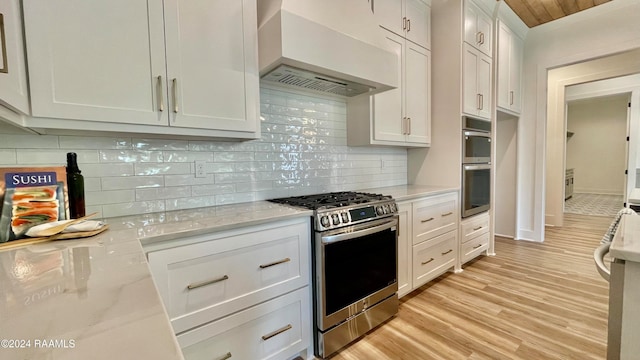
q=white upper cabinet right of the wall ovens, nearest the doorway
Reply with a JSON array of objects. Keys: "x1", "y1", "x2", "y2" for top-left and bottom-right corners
[{"x1": 497, "y1": 21, "x2": 523, "y2": 114}]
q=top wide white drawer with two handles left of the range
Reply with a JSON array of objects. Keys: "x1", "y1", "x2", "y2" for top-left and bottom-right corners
[{"x1": 148, "y1": 222, "x2": 310, "y2": 333}]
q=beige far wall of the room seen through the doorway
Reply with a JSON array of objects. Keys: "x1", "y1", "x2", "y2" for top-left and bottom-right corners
[{"x1": 566, "y1": 94, "x2": 629, "y2": 195}]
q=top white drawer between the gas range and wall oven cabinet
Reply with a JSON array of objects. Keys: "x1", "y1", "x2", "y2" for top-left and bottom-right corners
[{"x1": 413, "y1": 193, "x2": 458, "y2": 245}]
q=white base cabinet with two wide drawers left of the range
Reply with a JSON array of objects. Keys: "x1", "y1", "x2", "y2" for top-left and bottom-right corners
[{"x1": 147, "y1": 217, "x2": 312, "y2": 359}]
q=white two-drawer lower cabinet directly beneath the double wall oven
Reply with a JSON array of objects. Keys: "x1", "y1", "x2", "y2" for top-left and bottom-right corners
[{"x1": 460, "y1": 212, "x2": 490, "y2": 265}]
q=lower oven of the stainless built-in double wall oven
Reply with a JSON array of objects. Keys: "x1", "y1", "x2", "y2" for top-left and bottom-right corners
[{"x1": 462, "y1": 164, "x2": 491, "y2": 218}]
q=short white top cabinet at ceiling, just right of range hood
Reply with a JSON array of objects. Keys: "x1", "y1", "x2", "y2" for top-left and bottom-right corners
[{"x1": 374, "y1": 0, "x2": 431, "y2": 49}]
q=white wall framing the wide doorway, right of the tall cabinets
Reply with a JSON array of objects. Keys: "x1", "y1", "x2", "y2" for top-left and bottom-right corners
[{"x1": 518, "y1": 0, "x2": 640, "y2": 241}]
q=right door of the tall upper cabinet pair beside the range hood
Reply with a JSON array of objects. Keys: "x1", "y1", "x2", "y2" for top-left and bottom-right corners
[{"x1": 404, "y1": 42, "x2": 431, "y2": 144}]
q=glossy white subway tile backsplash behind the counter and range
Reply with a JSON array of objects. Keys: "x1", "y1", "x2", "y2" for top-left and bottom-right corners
[{"x1": 0, "y1": 87, "x2": 407, "y2": 217}]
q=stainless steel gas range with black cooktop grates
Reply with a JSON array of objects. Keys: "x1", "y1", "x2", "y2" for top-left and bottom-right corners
[{"x1": 270, "y1": 192, "x2": 398, "y2": 358}]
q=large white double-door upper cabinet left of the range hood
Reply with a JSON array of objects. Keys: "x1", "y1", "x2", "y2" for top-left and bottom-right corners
[{"x1": 24, "y1": 0, "x2": 259, "y2": 137}]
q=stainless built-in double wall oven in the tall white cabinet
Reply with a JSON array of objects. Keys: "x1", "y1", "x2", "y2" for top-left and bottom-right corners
[{"x1": 461, "y1": 116, "x2": 492, "y2": 218}]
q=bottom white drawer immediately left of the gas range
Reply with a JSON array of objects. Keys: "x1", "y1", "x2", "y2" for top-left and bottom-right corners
[{"x1": 177, "y1": 287, "x2": 310, "y2": 360}]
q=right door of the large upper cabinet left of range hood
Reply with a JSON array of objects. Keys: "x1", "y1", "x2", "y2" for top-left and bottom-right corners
[{"x1": 164, "y1": 0, "x2": 259, "y2": 131}]
